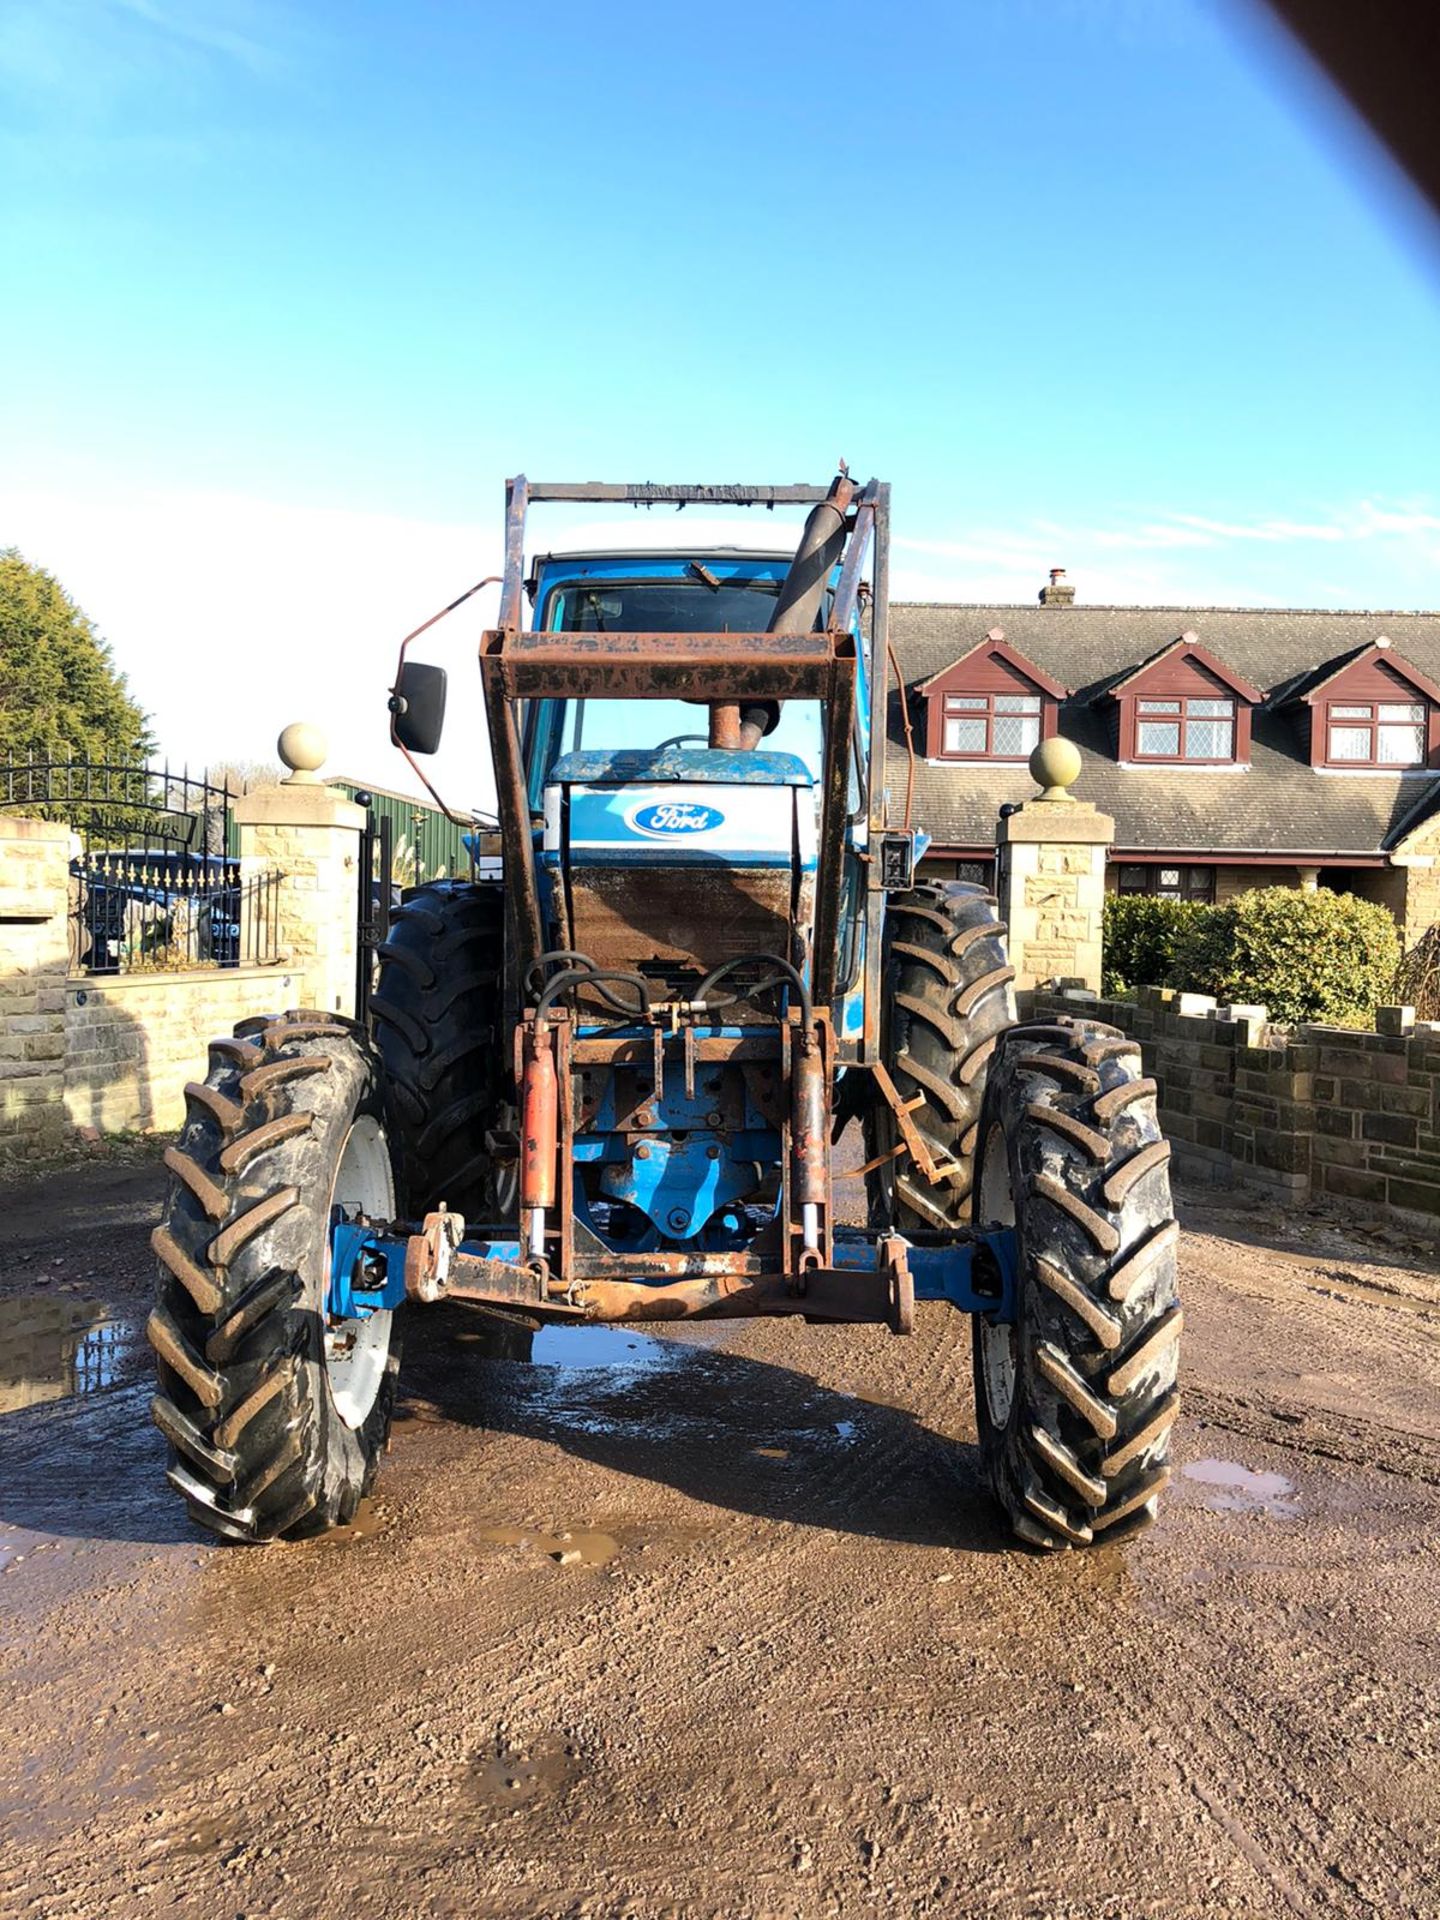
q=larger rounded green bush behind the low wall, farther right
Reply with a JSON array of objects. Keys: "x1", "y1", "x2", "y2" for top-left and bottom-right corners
[{"x1": 1167, "y1": 887, "x2": 1400, "y2": 1023}]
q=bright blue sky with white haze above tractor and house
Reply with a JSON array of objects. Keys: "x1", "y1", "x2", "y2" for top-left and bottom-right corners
[{"x1": 0, "y1": 0, "x2": 1440, "y2": 794}]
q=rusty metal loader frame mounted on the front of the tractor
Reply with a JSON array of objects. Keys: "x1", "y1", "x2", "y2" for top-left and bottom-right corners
[{"x1": 480, "y1": 474, "x2": 898, "y2": 1317}]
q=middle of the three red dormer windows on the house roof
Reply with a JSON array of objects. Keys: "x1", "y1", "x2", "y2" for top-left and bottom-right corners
[{"x1": 1110, "y1": 634, "x2": 1263, "y2": 766}]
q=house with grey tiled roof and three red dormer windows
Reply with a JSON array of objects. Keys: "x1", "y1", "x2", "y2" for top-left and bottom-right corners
[{"x1": 891, "y1": 570, "x2": 1440, "y2": 941}]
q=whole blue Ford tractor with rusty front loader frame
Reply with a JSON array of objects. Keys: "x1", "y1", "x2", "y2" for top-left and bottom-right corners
[{"x1": 150, "y1": 472, "x2": 1181, "y2": 1549}]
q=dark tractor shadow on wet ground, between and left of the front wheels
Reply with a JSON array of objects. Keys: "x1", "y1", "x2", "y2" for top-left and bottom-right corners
[{"x1": 0, "y1": 1306, "x2": 1006, "y2": 1553}]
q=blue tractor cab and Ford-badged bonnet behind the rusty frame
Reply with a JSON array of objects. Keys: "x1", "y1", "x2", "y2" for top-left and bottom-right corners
[{"x1": 524, "y1": 549, "x2": 868, "y2": 1023}]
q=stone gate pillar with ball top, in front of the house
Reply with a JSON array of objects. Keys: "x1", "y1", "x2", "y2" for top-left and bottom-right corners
[{"x1": 996, "y1": 735, "x2": 1116, "y2": 993}]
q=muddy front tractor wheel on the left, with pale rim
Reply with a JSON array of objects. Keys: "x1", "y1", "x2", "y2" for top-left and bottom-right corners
[{"x1": 146, "y1": 1014, "x2": 399, "y2": 1542}]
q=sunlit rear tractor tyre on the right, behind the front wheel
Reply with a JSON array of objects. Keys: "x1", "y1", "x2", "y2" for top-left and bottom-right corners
[{"x1": 866, "y1": 881, "x2": 1016, "y2": 1231}]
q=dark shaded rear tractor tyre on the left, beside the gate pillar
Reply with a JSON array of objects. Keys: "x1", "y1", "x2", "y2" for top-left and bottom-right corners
[{"x1": 371, "y1": 879, "x2": 518, "y2": 1221}]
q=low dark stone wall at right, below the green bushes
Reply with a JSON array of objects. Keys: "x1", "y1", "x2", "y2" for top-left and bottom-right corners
[{"x1": 1027, "y1": 987, "x2": 1440, "y2": 1227}]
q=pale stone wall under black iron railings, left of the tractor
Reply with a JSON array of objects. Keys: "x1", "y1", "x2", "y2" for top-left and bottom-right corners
[{"x1": 61, "y1": 968, "x2": 300, "y2": 1133}]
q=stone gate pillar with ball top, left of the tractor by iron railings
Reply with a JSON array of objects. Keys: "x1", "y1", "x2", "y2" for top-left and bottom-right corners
[{"x1": 234, "y1": 724, "x2": 365, "y2": 1014}]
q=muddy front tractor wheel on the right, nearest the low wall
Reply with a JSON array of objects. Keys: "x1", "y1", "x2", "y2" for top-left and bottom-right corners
[{"x1": 973, "y1": 1020, "x2": 1181, "y2": 1549}]
